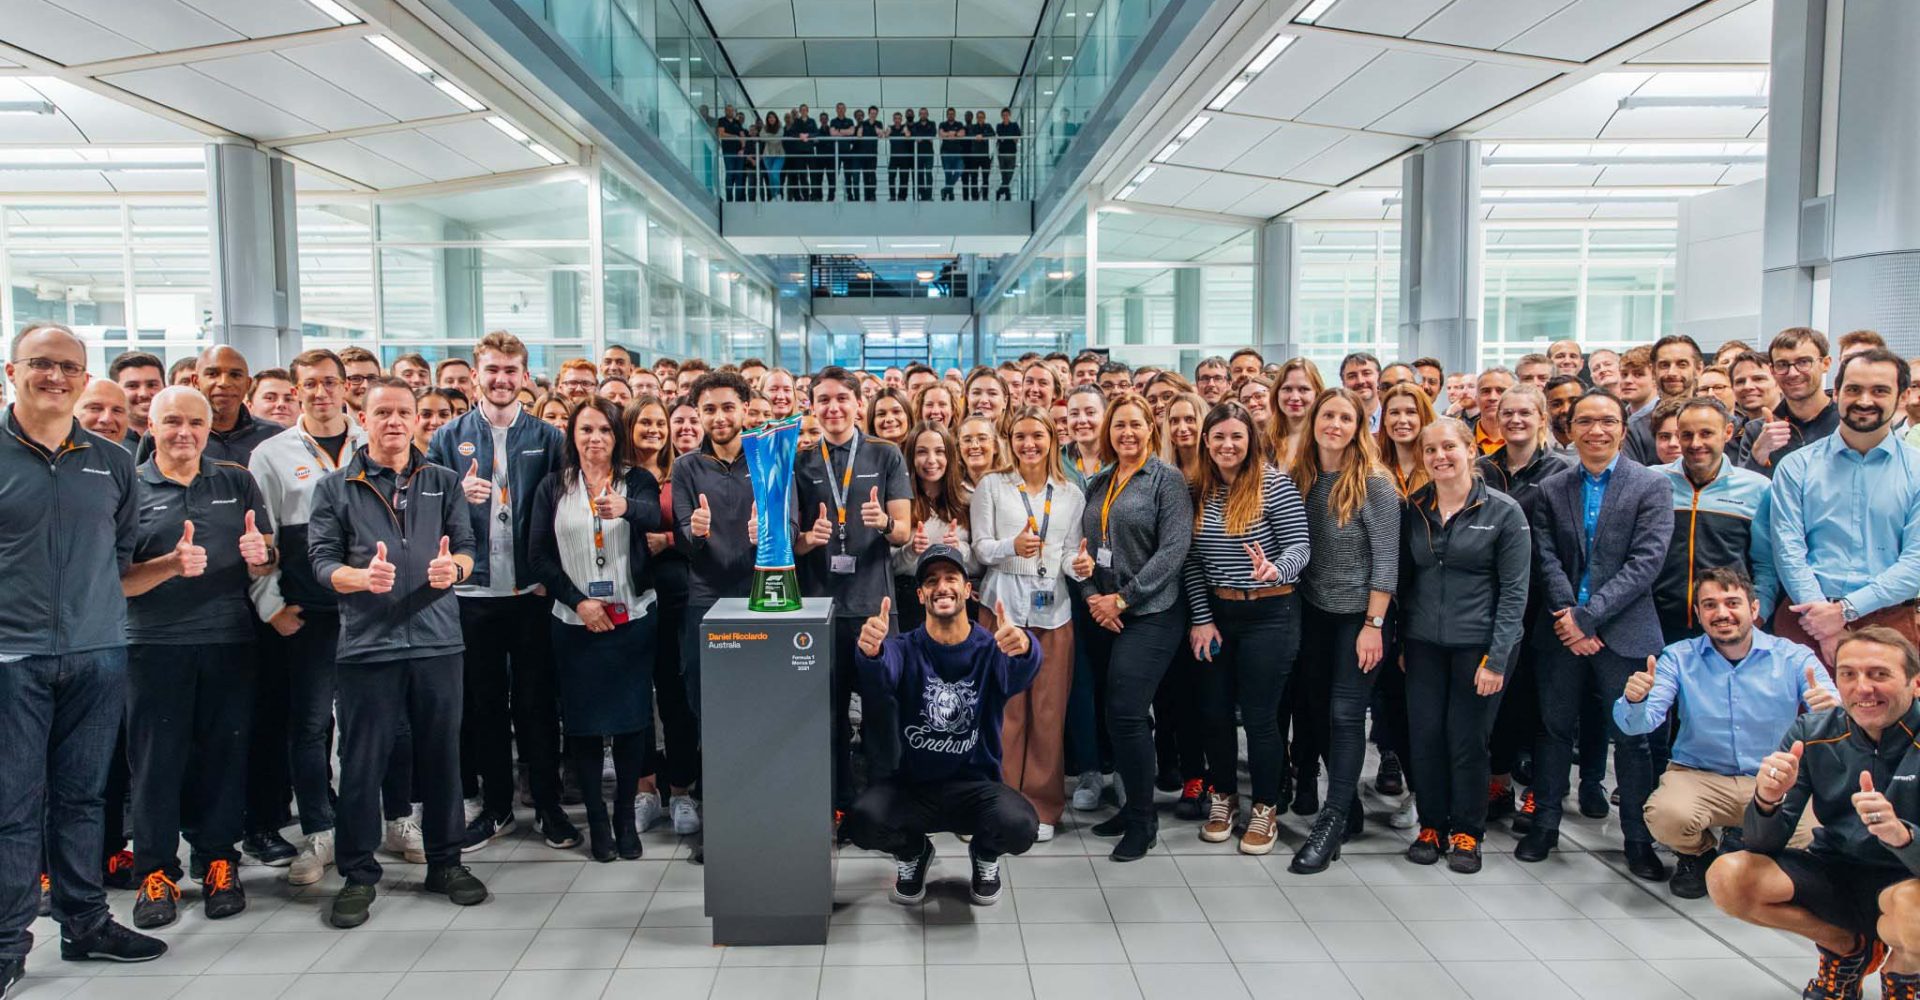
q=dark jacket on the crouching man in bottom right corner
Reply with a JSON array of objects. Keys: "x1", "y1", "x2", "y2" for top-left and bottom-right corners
[{"x1": 1745, "y1": 701, "x2": 1920, "y2": 875}]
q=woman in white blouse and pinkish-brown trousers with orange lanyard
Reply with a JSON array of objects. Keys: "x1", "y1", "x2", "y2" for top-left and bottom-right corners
[{"x1": 973, "y1": 407, "x2": 1087, "y2": 841}]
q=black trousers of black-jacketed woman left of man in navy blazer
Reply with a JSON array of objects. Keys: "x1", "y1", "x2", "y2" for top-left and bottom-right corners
[{"x1": 1404, "y1": 639, "x2": 1503, "y2": 839}]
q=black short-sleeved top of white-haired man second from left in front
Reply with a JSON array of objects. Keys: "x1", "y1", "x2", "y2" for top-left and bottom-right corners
[{"x1": 127, "y1": 455, "x2": 273, "y2": 645}]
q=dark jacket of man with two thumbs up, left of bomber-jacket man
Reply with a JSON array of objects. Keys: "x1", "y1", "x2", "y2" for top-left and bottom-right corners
[{"x1": 307, "y1": 447, "x2": 476, "y2": 662}]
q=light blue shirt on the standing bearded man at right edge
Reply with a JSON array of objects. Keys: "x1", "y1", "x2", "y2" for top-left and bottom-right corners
[{"x1": 1772, "y1": 434, "x2": 1920, "y2": 614}]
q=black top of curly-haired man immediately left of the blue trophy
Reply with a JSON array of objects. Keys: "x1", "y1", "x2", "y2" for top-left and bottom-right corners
[{"x1": 672, "y1": 441, "x2": 755, "y2": 610}]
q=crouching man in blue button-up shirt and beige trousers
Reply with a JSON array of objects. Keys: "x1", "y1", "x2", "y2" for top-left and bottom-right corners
[{"x1": 1613, "y1": 566, "x2": 1839, "y2": 900}]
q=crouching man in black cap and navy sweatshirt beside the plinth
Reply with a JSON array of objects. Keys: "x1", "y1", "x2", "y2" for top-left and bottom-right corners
[{"x1": 845, "y1": 543, "x2": 1041, "y2": 906}]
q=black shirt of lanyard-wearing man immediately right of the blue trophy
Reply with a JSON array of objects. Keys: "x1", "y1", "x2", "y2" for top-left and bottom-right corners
[{"x1": 793, "y1": 432, "x2": 912, "y2": 618}]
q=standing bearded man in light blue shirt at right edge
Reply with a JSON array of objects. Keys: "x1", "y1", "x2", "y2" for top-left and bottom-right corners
[{"x1": 1772, "y1": 347, "x2": 1920, "y2": 662}]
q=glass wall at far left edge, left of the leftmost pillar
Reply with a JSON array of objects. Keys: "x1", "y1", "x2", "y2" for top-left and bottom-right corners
[{"x1": 0, "y1": 194, "x2": 213, "y2": 372}]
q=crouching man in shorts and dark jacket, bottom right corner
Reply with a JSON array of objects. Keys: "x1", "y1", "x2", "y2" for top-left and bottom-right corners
[{"x1": 1707, "y1": 626, "x2": 1920, "y2": 1000}]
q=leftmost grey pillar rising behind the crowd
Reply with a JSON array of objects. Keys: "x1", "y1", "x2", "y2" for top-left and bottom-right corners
[{"x1": 205, "y1": 142, "x2": 300, "y2": 370}]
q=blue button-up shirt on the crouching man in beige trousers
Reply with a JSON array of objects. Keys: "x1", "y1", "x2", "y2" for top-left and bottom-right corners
[{"x1": 1613, "y1": 630, "x2": 1839, "y2": 775}]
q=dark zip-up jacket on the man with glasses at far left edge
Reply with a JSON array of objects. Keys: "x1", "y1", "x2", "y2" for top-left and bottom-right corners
[{"x1": 0, "y1": 407, "x2": 140, "y2": 656}]
